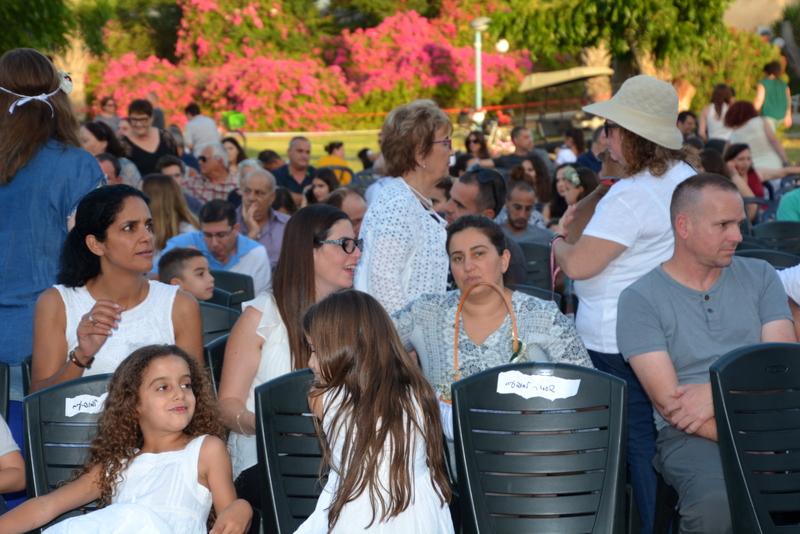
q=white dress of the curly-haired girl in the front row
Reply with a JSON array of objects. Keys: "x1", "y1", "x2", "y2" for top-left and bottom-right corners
[{"x1": 45, "y1": 436, "x2": 211, "y2": 534}]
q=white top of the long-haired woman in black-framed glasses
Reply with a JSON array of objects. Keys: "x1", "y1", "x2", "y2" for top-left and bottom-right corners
[{"x1": 228, "y1": 291, "x2": 292, "y2": 480}]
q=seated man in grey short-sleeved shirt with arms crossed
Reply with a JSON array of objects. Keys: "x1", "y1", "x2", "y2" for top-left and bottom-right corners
[{"x1": 617, "y1": 173, "x2": 796, "y2": 534}]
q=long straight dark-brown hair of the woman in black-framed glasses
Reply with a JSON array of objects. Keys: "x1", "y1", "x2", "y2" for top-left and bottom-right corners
[{"x1": 272, "y1": 204, "x2": 350, "y2": 370}]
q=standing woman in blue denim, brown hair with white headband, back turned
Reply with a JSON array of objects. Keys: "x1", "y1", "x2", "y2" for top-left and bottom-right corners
[{"x1": 0, "y1": 48, "x2": 104, "y2": 368}]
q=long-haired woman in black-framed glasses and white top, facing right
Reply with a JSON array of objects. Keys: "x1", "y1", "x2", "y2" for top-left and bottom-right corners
[{"x1": 218, "y1": 204, "x2": 363, "y2": 508}]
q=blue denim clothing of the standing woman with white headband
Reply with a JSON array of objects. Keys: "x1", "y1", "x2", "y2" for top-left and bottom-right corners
[{"x1": 0, "y1": 139, "x2": 105, "y2": 364}]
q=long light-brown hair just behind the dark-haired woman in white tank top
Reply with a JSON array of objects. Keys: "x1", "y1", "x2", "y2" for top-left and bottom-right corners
[{"x1": 142, "y1": 173, "x2": 200, "y2": 265}]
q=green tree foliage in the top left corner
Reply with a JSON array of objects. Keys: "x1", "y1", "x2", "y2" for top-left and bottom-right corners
[{"x1": 0, "y1": 0, "x2": 73, "y2": 54}]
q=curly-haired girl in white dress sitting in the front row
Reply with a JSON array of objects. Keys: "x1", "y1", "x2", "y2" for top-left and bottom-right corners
[{"x1": 0, "y1": 345, "x2": 253, "y2": 534}]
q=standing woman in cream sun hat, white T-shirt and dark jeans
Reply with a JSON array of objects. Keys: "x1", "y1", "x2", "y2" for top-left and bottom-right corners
[{"x1": 553, "y1": 75, "x2": 696, "y2": 532}]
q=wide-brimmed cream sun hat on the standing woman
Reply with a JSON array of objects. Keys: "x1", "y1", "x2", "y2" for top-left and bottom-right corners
[{"x1": 583, "y1": 74, "x2": 683, "y2": 150}]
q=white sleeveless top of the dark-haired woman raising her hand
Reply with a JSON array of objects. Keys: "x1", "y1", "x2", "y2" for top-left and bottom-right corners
[{"x1": 55, "y1": 280, "x2": 178, "y2": 376}]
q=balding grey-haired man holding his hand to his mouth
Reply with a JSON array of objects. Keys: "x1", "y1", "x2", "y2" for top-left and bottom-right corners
[{"x1": 236, "y1": 169, "x2": 290, "y2": 269}]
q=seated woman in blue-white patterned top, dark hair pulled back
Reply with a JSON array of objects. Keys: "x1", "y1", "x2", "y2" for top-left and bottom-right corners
[{"x1": 392, "y1": 215, "x2": 593, "y2": 398}]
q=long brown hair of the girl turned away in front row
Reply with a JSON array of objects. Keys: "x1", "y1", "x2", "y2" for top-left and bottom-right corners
[{"x1": 303, "y1": 290, "x2": 450, "y2": 532}]
